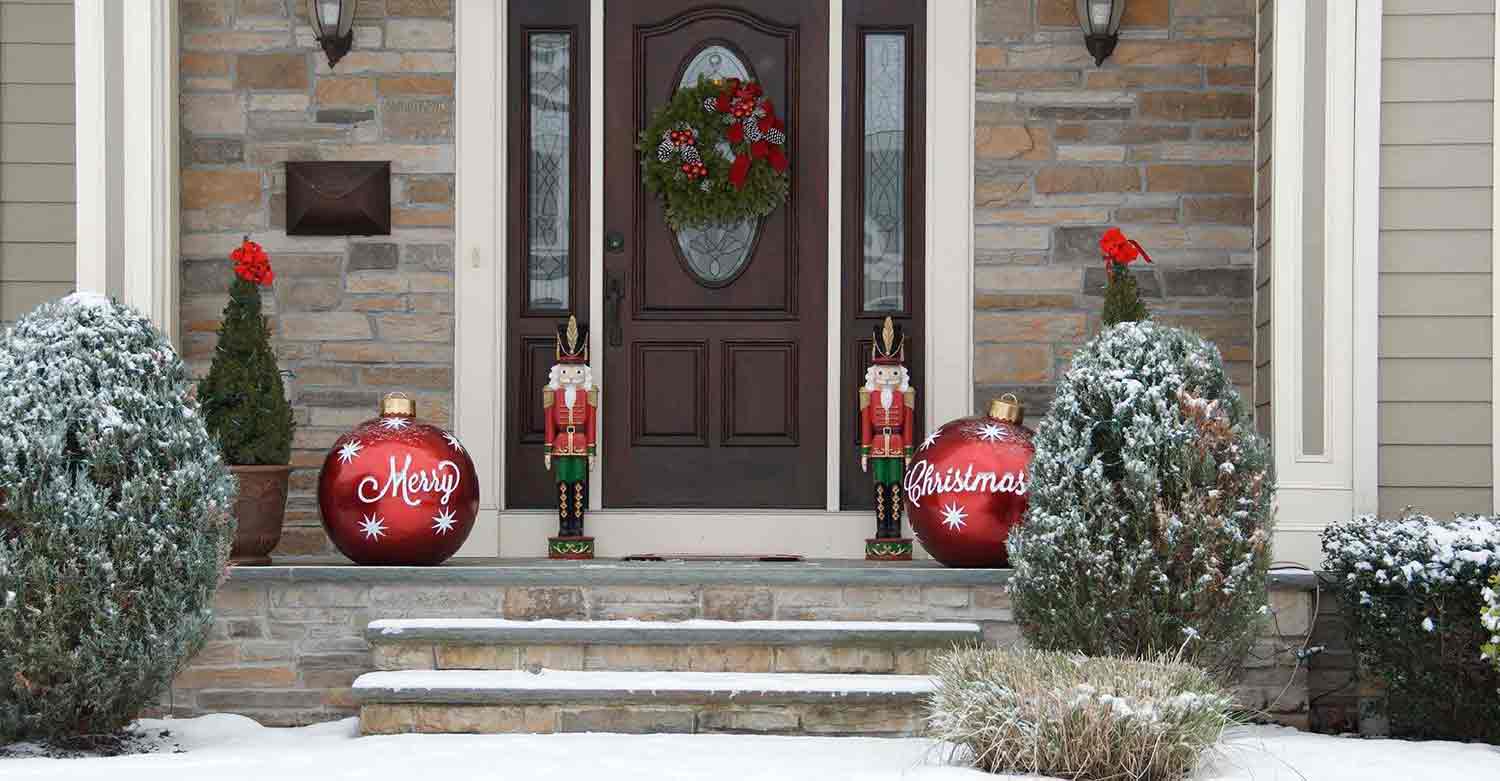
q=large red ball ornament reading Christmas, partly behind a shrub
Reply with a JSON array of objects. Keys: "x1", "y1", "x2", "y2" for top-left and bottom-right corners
[{"x1": 903, "y1": 396, "x2": 1037, "y2": 567}]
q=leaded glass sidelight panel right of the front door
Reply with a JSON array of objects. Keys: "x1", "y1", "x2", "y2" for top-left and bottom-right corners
[{"x1": 863, "y1": 33, "x2": 906, "y2": 312}]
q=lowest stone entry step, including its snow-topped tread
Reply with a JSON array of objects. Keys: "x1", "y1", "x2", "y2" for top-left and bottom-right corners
[{"x1": 353, "y1": 670, "x2": 933, "y2": 736}]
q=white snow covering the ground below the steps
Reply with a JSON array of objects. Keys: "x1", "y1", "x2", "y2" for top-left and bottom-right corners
[{"x1": 0, "y1": 715, "x2": 1500, "y2": 781}]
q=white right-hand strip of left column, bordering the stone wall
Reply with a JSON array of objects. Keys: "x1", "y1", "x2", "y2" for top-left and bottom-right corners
[{"x1": 119, "y1": 0, "x2": 179, "y2": 343}]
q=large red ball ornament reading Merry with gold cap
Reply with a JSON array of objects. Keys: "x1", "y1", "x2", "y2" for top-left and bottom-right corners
[{"x1": 318, "y1": 396, "x2": 479, "y2": 565}]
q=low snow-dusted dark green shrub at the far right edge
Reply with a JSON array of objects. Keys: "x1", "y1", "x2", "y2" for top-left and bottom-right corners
[{"x1": 1323, "y1": 514, "x2": 1500, "y2": 742}]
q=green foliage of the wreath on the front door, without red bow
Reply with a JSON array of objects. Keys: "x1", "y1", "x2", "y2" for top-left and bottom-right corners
[{"x1": 636, "y1": 78, "x2": 791, "y2": 231}]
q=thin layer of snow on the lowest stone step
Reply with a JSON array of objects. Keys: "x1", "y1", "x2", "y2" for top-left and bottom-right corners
[{"x1": 354, "y1": 670, "x2": 933, "y2": 694}]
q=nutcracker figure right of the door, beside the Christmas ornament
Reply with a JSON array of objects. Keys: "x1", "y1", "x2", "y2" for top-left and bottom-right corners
[{"x1": 860, "y1": 318, "x2": 917, "y2": 561}]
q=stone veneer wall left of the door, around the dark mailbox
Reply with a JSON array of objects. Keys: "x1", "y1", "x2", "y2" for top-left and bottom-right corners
[{"x1": 179, "y1": 0, "x2": 455, "y2": 555}]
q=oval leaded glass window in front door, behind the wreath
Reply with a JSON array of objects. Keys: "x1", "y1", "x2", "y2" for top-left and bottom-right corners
[{"x1": 677, "y1": 43, "x2": 761, "y2": 288}]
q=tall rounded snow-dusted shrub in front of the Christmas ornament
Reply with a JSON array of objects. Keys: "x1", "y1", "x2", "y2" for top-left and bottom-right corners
[{"x1": 1010, "y1": 321, "x2": 1275, "y2": 673}]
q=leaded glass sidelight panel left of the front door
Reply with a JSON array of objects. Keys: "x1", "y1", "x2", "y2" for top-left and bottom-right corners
[{"x1": 527, "y1": 33, "x2": 573, "y2": 310}]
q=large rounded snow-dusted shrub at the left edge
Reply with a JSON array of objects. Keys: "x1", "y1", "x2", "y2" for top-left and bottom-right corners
[{"x1": 0, "y1": 294, "x2": 234, "y2": 742}]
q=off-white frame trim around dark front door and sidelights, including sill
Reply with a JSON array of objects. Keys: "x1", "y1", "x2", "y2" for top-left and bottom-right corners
[{"x1": 453, "y1": 0, "x2": 975, "y2": 558}]
